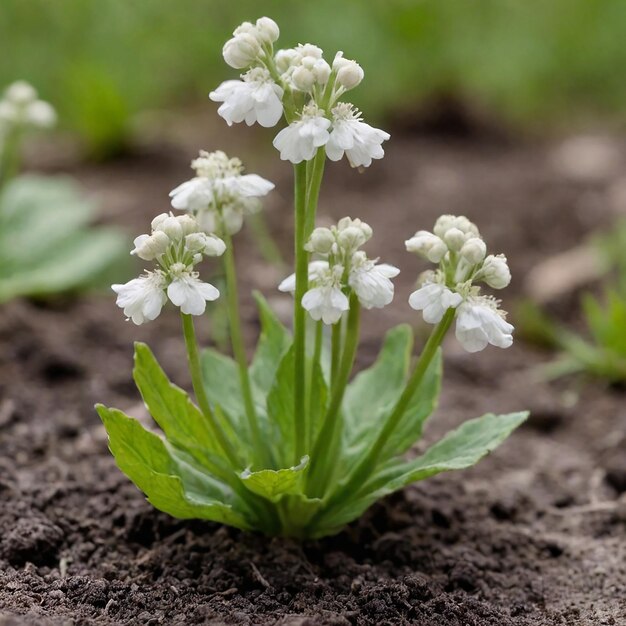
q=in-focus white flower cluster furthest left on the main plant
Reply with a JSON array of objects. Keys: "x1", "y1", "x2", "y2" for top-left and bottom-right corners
[{"x1": 112, "y1": 213, "x2": 226, "y2": 324}]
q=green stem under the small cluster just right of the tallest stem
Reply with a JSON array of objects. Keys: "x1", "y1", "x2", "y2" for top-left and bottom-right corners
[{"x1": 307, "y1": 293, "x2": 361, "y2": 496}]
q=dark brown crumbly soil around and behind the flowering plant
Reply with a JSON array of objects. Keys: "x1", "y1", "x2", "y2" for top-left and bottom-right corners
[{"x1": 0, "y1": 129, "x2": 626, "y2": 626}]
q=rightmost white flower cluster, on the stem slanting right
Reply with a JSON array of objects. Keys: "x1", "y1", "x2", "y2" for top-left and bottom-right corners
[{"x1": 406, "y1": 215, "x2": 513, "y2": 352}]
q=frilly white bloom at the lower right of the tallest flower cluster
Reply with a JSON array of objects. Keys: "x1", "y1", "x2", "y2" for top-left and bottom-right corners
[{"x1": 326, "y1": 102, "x2": 391, "y2": 167}]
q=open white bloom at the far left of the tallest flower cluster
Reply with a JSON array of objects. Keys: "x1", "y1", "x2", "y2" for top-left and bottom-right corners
[{"x1": 209, "y1": 67, "x2": 283, "y2": 128}]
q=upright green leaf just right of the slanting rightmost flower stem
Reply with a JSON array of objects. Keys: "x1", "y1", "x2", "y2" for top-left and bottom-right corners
[{"x1": 382, "y1": 348, "x2": 443, "y2": 458}]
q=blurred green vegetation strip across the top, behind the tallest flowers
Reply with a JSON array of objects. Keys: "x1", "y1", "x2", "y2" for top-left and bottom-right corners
[{"x1": 0, "y1": 0, "x2": 626, "y2": 158}]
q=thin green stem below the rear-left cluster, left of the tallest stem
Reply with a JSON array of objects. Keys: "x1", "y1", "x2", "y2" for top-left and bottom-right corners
[{"x1": 223, "y1": 229, "x2": 271, "y2": 467}]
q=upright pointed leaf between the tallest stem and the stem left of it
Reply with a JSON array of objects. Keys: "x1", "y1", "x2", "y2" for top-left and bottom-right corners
[{"x1": 250, "y1": 292, "x2": 291, "y2": 397}]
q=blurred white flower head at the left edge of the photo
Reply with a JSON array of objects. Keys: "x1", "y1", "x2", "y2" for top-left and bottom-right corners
[{"x1": 0, "y1": 80, "x2": 56, "y2": 136}]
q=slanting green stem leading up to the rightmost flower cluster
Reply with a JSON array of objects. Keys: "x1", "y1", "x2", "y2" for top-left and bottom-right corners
[{"x1": 315, "y1": 309, "x2": 455, "y2": 521}]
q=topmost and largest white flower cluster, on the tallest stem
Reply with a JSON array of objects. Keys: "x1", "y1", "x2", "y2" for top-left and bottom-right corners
[{"x1": 209, "y1": 17, "x2": 390, "y2": 167}]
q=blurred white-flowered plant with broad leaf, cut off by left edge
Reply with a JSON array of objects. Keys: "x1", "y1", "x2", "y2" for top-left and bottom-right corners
[{"x1": 0, "y1": 81, "x2": 126, "y2": 302}]
